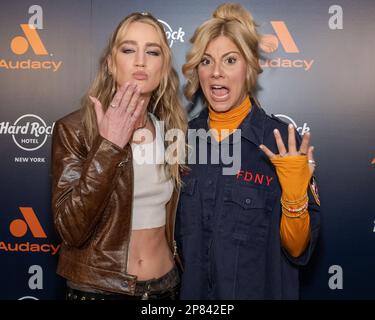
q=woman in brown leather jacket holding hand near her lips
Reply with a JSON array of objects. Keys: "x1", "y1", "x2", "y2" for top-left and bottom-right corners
[{"x1": 52, "y1": 13, "x2": 186, "y2": 300}]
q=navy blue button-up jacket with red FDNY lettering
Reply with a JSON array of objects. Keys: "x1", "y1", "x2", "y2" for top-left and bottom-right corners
[{"x1": 175, "y1": 101, "x2": 320, "y2": 299}]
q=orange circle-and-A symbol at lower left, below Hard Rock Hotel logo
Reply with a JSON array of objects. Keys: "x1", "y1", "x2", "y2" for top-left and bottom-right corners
[{"x1": 9, "y1": 207, "x2": 47, "y2": 238}]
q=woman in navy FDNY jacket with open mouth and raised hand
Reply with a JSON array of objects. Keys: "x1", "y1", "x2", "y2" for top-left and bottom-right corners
[{"x1": 175, "y1": 4, "x2": 320, "y2": 299}]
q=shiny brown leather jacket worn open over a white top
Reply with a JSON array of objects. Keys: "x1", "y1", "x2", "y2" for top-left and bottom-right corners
[{"x1": 52, "y1": 111, "x2": 179, "y2": 295}]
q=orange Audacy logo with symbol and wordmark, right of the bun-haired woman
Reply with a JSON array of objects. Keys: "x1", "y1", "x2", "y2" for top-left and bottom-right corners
[{"x1": 259, "y1": 21, "x2": 314, "y2": 71}]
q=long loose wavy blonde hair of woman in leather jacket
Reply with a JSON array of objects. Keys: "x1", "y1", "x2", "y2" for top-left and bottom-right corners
[{"x1": 81, "y1": 12, "x2": 187, "y2": 186}]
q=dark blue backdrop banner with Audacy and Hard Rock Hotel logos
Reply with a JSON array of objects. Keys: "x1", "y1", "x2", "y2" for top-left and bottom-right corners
[{"x1": 0, "y1": 0, "x2": 375, "y2": 299}]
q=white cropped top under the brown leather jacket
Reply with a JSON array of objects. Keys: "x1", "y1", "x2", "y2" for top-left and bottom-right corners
[{"x1": 131, "y1": 113, "x2": 173, "y2": 230}]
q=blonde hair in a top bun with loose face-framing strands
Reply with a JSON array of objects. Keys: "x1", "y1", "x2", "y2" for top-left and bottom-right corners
[{"x1": 182, "y1": 3, "x2": 262, "y2": 102}]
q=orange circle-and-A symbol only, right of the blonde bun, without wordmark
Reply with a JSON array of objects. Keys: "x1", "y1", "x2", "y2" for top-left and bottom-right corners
[{"x1": 260, "y1": 21, "x2": 299, "y2": 53}]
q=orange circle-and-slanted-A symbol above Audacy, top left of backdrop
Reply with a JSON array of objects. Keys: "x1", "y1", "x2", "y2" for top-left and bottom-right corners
[{"x1": 10, "y1": 23, "x2": 48, "y2": 55}]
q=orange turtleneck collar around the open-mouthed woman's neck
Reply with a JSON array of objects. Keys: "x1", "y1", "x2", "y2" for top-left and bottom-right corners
[{"x1": 208, "y1": 96, "x2": 251, "y2": 141}]
